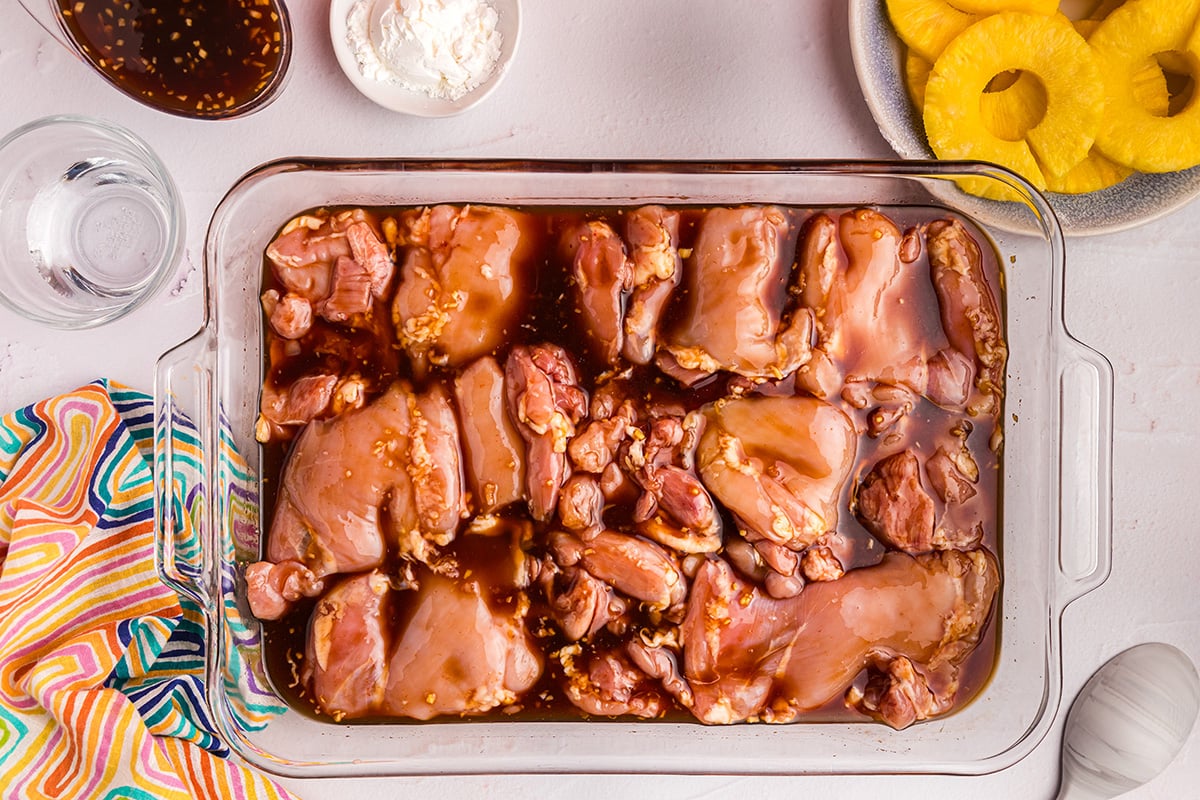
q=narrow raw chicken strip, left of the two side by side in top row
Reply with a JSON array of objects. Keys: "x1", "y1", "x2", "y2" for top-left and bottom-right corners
[{"x1": 560, "y1": 221, "x2": 634, "y2": 365}]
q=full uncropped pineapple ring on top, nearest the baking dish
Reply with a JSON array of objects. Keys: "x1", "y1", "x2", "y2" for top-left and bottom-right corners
[{"x1": 924, "y1": 12, "x2": 1099, "y2": 188}]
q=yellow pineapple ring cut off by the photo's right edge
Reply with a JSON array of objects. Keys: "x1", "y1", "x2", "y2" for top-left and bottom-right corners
[{"x1": 1088, "y1": 0, "x2": 1200, "y2": 173}]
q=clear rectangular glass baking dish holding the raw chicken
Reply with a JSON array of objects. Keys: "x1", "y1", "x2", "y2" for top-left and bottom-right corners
[{"x1": 156, "y1": 160, "x2": 1112, "y2": 777}]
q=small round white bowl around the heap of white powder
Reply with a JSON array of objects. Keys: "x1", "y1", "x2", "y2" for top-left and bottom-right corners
[{"x1": 329, "y1": 0, "x2": 521, "y2": 116}]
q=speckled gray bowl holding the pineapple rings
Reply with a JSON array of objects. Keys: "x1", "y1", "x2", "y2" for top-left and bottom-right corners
[{"x1": 850, "y1": 0, "x2": 1200, "y2": 236}]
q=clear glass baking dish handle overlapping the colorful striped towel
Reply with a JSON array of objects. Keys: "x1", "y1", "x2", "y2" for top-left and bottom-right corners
[{"x1": 154, "y1": 331, "x2": 212, "y2": 608}]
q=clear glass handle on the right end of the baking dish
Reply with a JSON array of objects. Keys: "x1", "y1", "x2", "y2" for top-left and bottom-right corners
[{"x1": 1057, "y1": 338, "x2": 1112, "y2": 607}]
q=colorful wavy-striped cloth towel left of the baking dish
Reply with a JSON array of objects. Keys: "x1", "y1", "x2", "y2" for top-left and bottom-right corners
[{"x1": 0, "y1": 380, "x2": 297, "y2": 800}]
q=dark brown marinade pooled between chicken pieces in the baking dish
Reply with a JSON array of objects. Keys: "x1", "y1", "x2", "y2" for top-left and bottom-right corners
[{"x1": 260, "y1": 206, "x2": 1006, "y2": 724}]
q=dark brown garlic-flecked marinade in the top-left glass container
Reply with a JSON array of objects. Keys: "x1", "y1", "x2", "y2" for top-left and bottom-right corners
[{"x1": 58, "y1": 0, "x2": 286, "y2": 118}]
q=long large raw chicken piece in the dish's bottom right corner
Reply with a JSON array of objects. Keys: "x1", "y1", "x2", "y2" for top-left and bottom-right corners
[{"x1": 680, "y1": 551, "x2": 1000, "y2": 723}]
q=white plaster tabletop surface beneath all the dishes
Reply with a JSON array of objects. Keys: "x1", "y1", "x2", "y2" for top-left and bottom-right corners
[{"x1": 0, "y1": 0, "x2": 1200, "y2": 800}]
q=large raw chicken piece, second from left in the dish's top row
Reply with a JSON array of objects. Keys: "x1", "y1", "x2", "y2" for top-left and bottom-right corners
[{"x1": 392, "y1": 205, "x2": 539, "y2": 373}]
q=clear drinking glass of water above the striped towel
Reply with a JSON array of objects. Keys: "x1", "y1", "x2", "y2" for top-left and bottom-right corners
[{"x1": 0, "y1": 116, "x2": 184, "y2": 329}]
